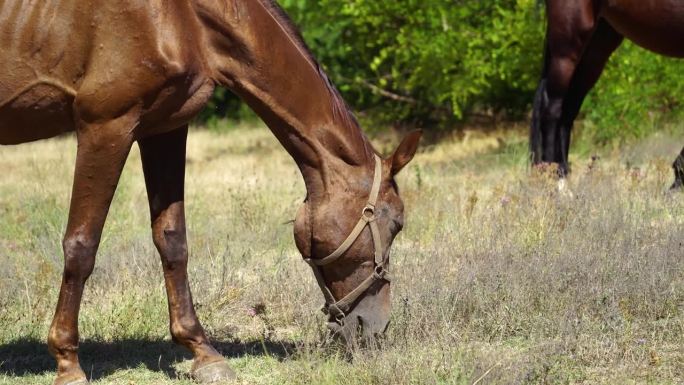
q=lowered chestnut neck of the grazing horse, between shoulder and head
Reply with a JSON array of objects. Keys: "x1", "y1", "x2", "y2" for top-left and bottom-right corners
[{"x1": 195, "y1": 0, "x2": 373, "y2": 197}]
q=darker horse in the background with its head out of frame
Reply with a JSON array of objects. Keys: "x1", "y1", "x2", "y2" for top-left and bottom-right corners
[{"x1": 530, "y1": 0, "x2": 684, "y2": 187}]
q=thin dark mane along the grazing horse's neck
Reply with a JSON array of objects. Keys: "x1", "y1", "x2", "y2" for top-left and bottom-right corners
[{"x1": 258, "y1": 0, "x2": 360, "y2": 136}]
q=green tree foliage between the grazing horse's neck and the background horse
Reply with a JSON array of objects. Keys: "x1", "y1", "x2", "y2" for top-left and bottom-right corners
[{"x1": 282, "y1": 0, "x2": 543, "y2": 126}]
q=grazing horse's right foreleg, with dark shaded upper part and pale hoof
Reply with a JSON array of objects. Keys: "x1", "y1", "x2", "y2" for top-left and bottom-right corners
[{"x1": 138, "y1": 126, "x2": 234, "y2": 383}]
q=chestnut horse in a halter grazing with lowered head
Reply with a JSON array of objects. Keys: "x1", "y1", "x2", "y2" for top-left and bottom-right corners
[{"x1": 0, "y1": 0, "x2": 420, "y2": 385}]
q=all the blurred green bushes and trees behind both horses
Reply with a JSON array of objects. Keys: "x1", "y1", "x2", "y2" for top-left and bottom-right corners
[{"x1": 196, "y1": 0, "x2": 684, "y2": 144}]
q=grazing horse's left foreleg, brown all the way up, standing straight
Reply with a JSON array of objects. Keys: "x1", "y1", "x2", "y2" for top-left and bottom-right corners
[{"x1": 48, "y1": 116, "x2": 135, "y2": 385}]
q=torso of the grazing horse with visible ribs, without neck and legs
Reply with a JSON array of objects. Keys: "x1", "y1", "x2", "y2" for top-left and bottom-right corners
[{"x1": 0, "y1": 0, "x2": 207, "y2": 144}]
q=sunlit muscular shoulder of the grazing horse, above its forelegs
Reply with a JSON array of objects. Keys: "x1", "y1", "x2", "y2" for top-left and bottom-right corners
[{"x1": 75, "y1": 2, "x2": 213, "y2": 125}]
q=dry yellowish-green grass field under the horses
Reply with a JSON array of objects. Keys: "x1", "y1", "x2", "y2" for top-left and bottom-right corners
[{"x1": 0, "y1": 124, "x2": 684, "y2": 385}]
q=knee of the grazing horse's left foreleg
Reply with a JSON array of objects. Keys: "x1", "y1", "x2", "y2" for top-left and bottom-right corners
[{"x1": 62, "y1": 234, "x2": 98, "y2": 284}]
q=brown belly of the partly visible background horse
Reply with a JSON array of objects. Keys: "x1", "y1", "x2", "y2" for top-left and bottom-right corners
[{"x1": 602, "y1": 0, "x2": 684, "y2": 57}]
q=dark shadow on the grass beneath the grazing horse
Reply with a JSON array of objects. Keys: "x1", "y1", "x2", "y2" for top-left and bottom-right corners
[{"x1": 0, "y1": 340, "x2": 296, "y2": 380}]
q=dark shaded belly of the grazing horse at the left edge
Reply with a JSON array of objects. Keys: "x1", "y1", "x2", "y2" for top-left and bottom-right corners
[{"x1": 0, "y1": 84, "x2": 74, "y2": 145}]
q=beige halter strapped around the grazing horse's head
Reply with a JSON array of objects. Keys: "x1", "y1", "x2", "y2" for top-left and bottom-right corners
[{"x1": 305, "y1": 154, "x2": 390, "y2": 325}]
